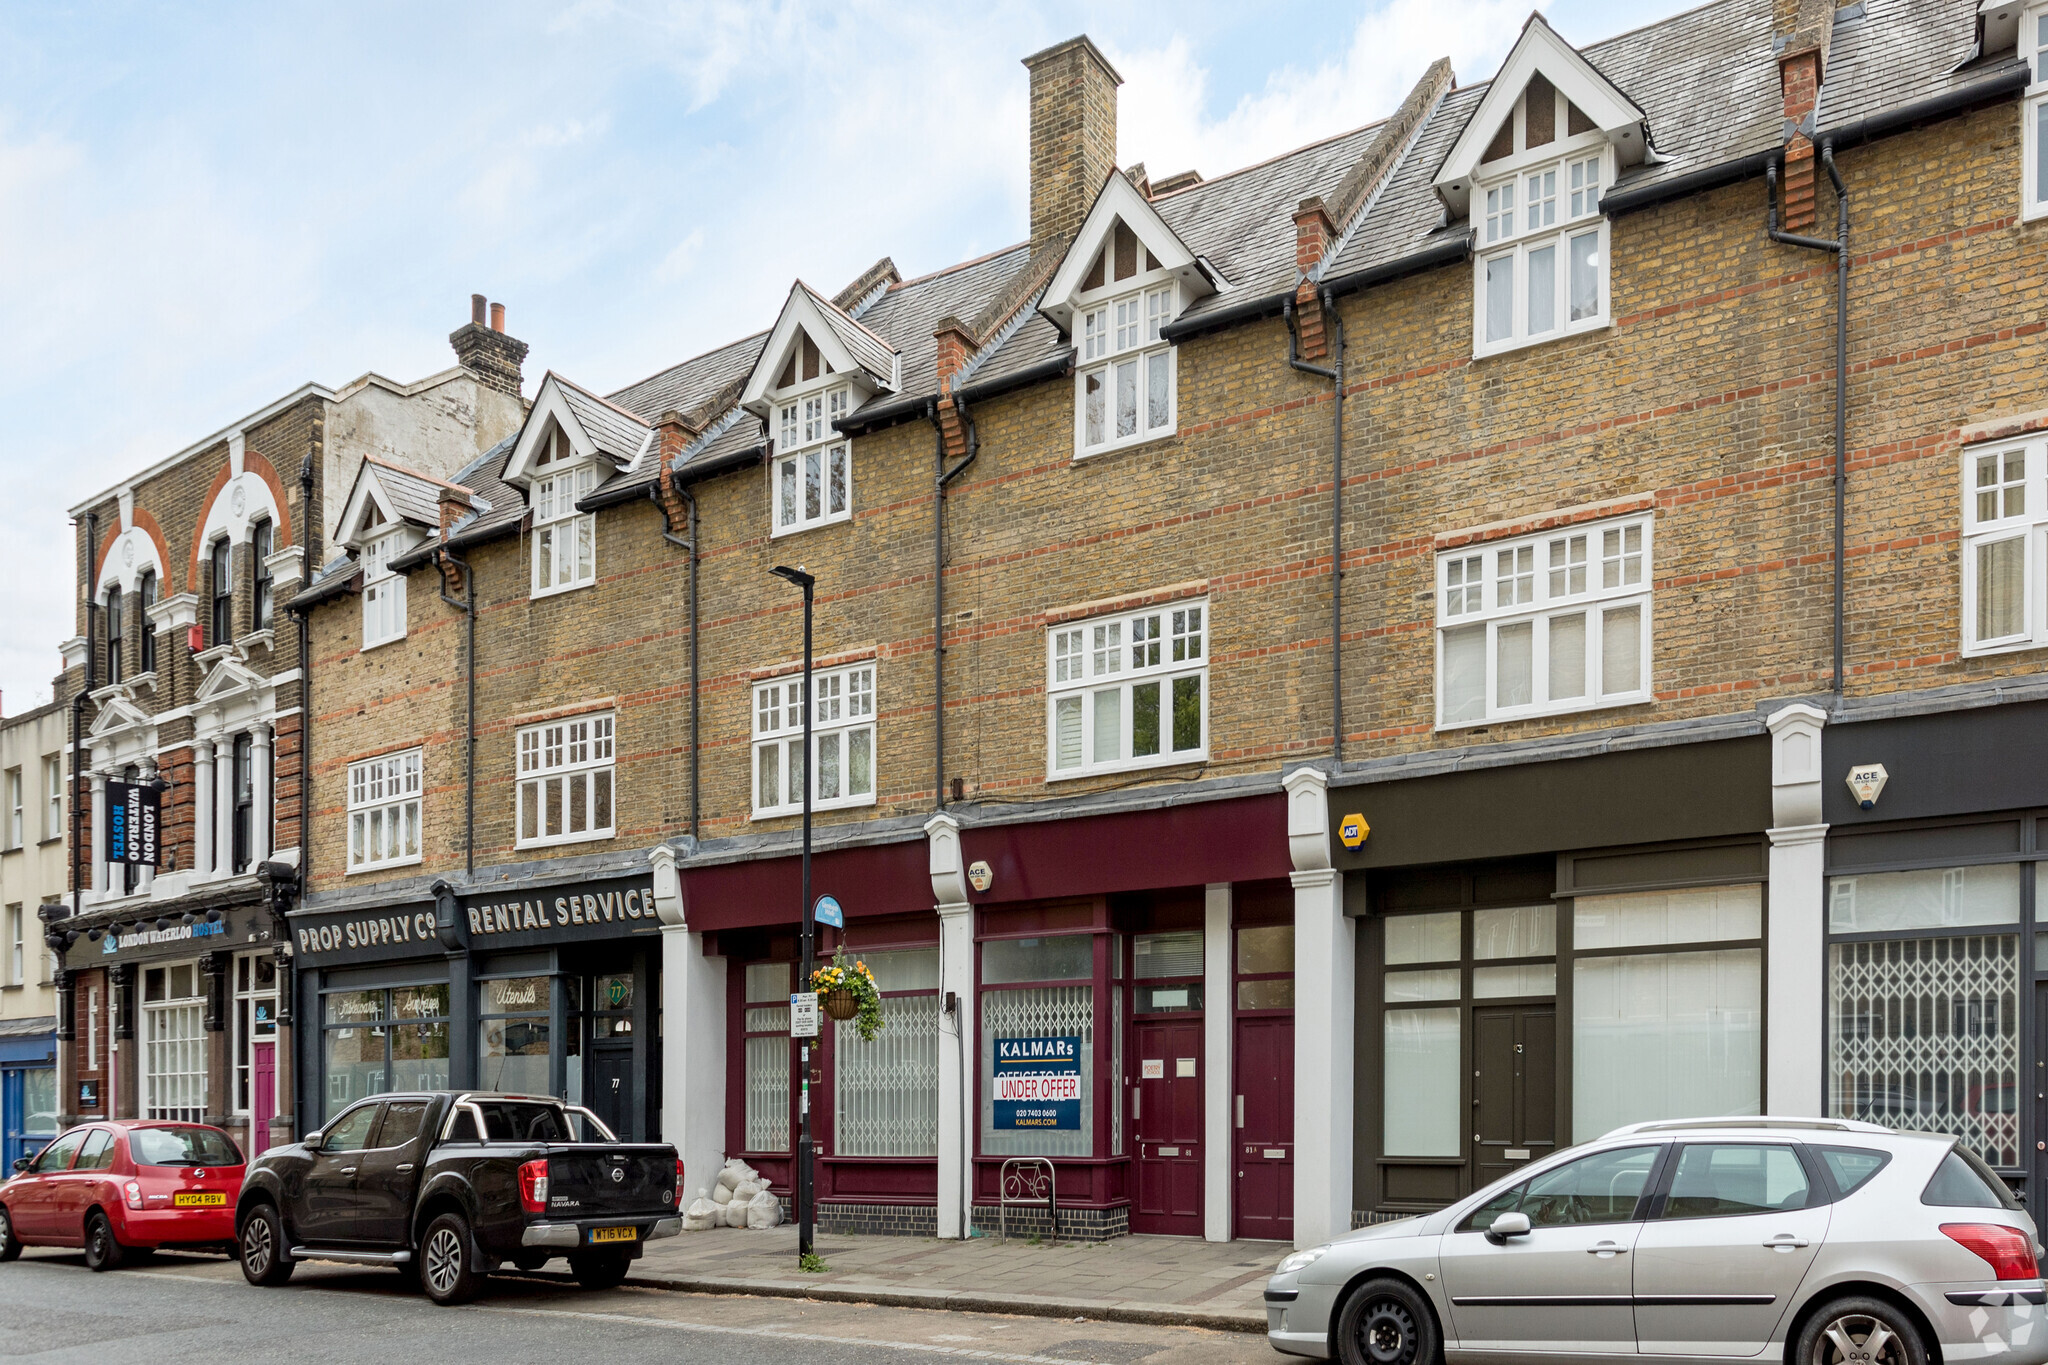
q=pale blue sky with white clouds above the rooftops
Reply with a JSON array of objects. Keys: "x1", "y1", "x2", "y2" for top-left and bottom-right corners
[{"x1": 0, "y1": 0, "x2": 1696, "y2": 714}]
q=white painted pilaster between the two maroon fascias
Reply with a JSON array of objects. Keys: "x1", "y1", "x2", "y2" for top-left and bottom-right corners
[{"x1": 924, "y1": 814, "x2": 977, "y2": 1238}]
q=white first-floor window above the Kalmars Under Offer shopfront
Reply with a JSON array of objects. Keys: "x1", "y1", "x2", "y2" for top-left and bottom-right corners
[{"x1": 1047, "y1": 600, "x2": 1208, "y2": 778}]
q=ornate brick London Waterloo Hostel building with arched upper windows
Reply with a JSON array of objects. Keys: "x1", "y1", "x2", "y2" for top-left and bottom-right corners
[{"x1": 47, "y1": 309, "x2": 524, "y2": 1152}]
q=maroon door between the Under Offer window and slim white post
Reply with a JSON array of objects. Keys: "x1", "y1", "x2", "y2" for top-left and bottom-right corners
[{"x1": 1130, "y1": 1015, "x2": 1202, "y2": 1236}]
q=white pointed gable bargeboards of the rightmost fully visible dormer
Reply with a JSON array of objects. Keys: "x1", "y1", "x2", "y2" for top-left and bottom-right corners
[{"x1": 1436, "y1": 14, "x2": 1651, "y2": 217}]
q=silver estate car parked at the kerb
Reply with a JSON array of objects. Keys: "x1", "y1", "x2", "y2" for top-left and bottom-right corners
[{"x1": 1266, "y1": 1117, "x2": 2048, "y2": 1365}]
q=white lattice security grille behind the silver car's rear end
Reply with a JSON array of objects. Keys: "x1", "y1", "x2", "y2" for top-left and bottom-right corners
[{"x1": 1829, "y1": 933, "x2": 2019, "y2": 1166}]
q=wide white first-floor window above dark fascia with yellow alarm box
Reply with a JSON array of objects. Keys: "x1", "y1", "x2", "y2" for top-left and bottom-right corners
[{"x1": 1436, "y1": 514, "x2": 1655, "y2": 731}]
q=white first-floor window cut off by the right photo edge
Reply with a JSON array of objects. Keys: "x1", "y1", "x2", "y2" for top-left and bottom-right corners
[{"x1": 1962, "y1": 440, "x2": 2048, "y2": 655}]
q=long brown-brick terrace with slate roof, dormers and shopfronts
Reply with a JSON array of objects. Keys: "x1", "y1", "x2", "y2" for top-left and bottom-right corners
[{"x1": 293, "y1": 0, "x2": 2048, "y2": 1242}]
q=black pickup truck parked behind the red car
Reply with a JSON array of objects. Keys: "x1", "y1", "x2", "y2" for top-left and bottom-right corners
[{"x1": 236, "y1": 1091, "x2": 682, "y2": 1304}]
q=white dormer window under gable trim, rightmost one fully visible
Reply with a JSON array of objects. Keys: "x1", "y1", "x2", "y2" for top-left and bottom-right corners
[{"x1": 1473, "y1": 76, "x2": 1614, "y2": 356}]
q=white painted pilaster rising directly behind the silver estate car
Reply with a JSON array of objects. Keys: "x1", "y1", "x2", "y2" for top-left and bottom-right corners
[{"x1": 1763, "y1": 702, "x2": 1827, "y2": 1115}]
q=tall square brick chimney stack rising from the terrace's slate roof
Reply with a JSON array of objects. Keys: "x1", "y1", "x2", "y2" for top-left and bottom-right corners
[{"x1": 1024, "y1": 35, "x2": 1124, "y2": 256}]
